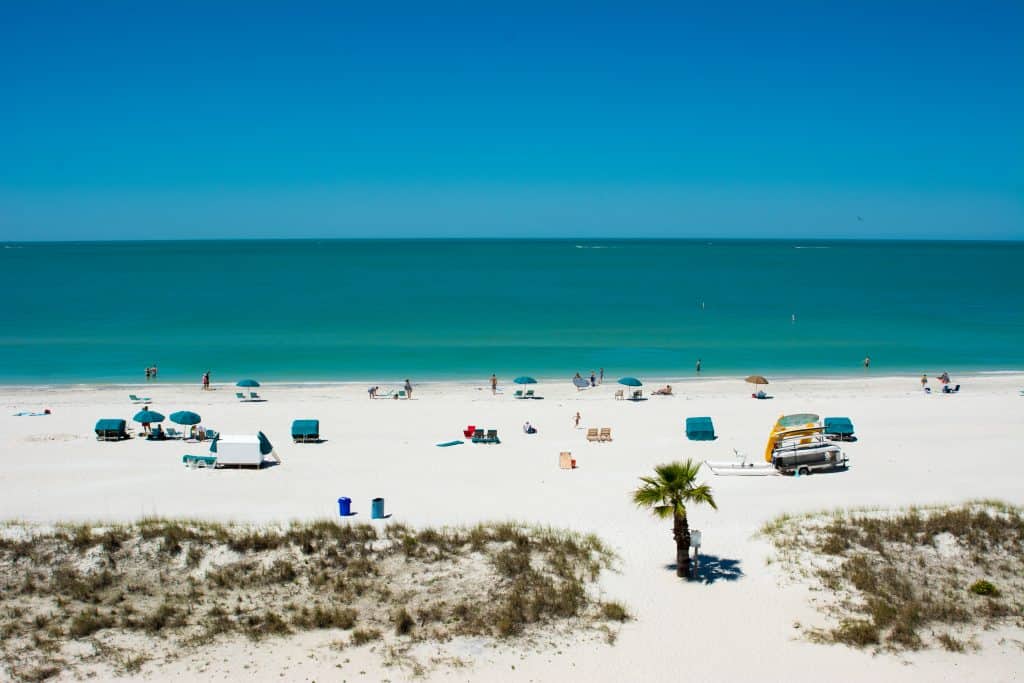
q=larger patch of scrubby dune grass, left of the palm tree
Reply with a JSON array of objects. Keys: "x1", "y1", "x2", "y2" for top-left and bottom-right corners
[{"x1": 0, "y1": 519, "x2": 629, "y2": 681}]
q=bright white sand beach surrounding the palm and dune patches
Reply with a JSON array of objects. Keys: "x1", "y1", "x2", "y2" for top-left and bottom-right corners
[{"x1": 0, "y1": 374, "x2": 1024, "y2": 681}]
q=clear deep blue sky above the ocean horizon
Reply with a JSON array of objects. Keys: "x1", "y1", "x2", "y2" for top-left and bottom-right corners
[{"x1": 0, "y1": 1, "x2": 1024, "y2": 240}]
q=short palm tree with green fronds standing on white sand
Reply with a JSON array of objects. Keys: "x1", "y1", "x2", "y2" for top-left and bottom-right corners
[{"x1": 633, "y1": 460, "x2": 718, "y2": 577}]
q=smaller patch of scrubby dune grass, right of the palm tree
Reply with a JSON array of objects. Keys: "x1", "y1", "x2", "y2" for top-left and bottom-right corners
[{"x1": 762, "y1": 501, "x2": 1024, "y2": 652}]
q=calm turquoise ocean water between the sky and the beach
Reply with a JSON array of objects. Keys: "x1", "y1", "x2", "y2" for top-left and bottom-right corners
[{"x1": 0, "y1": 240, "x2": 1024, "y2": 384}]
